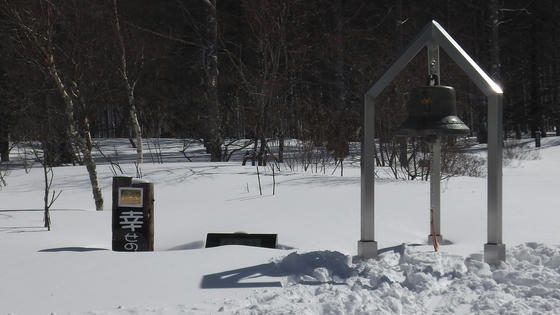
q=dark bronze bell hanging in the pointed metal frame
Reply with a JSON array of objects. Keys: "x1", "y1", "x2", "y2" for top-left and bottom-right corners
[{"x1": 395, "y1": 85, "x2": 470, "y2": 137}]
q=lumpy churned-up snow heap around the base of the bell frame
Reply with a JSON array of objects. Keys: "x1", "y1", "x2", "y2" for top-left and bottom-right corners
[{"x1": 225, "y1": 243, "x2": 560, "y2": 314}]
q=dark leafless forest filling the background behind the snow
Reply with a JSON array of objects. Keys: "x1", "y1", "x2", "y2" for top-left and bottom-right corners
[{"x1": 0, "y1": 0, "x2": 560, "y2": 170}]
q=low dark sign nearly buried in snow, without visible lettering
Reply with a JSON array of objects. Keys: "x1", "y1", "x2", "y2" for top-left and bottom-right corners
[{"x1": 206, "y1": 233, "x2": 278, "y2": 248}]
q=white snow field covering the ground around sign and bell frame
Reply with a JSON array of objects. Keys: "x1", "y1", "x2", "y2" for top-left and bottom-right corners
[{"x1": 0, "y1": 137, "x2": 560, "y2": 314}]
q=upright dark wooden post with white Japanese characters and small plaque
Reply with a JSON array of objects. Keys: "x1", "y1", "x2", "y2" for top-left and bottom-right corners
[{"x1": 112, "y1": 176, "x2": 154, "y2": 252}]
